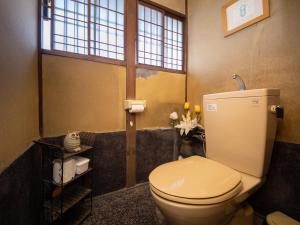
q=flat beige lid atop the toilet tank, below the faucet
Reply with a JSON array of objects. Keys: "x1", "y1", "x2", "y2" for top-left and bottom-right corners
[{"x1": 203, "y1": 88, "x2": 280, "y2": 100}]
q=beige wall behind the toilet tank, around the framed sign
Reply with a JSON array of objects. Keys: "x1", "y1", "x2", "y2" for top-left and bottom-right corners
[{"x1": 188, "y1": 0, "x2": 300, "y2": 143}]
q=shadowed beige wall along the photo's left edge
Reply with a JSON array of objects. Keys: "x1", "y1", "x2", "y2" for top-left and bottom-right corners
[{"x1": 0, "y1": 0, "x2": 38, "y2": 171}]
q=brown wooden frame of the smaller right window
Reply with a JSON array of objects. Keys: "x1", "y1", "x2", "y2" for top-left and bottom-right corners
[{"x1": 136, "y1": 0, "x2": 187, "y2": 74}]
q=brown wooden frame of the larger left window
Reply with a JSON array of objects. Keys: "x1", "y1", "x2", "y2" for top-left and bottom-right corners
[{"x1": 39, "y1": 0, "x2": 127, "y2": 66}]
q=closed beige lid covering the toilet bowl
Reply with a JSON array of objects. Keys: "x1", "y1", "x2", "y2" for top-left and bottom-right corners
[{"x1": 149, "y1": 156, "x2": 241, "y2": 199}]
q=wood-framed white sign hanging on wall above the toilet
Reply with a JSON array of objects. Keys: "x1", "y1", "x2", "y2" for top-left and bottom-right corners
[{"x1": 222, "y1": 0, "x2": 270, "y2": 37}]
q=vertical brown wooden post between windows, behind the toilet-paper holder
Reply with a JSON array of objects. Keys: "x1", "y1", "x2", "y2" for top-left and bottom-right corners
[{"x1": 125, "y1": 0, "x2": 137, "y2": 187}]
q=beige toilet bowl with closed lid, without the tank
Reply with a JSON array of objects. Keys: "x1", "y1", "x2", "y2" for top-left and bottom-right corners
[{"x1": 149, "y1": 156, "x2": 262, "y2": 225}]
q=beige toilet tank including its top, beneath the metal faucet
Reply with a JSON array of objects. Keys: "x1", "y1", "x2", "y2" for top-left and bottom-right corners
[{"x1": 203, "y1": 89, "x2": 280, "y2": 177}]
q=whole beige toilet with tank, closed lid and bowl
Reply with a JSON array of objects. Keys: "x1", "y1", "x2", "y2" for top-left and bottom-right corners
[{"x1": 149, "y1": 89, "x2": 280, "y2": 225}]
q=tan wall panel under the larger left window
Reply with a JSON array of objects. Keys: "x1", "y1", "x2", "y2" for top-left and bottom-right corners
[{"x1": 43, "y1": 55, "x2": 126, "y2": 136}]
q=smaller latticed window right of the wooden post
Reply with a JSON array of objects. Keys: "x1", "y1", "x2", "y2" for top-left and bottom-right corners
[{"x1": 137, "y1": 3, "x2": 184, "y2": 71}]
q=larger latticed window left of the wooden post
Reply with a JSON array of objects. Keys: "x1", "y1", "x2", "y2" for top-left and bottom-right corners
[{"x1": 42, "y1": 0, "x2": 125, "y2": 60}]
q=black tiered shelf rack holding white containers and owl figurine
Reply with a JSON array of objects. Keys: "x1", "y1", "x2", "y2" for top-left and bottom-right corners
[{"x1": 34, "y1": 140, "x2": 94, "y2": 225}]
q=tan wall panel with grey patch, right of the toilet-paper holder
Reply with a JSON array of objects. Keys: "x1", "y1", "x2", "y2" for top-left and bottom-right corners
[{"x1": 136, "y1": 72, "x2": 185, "y2": 129}]
